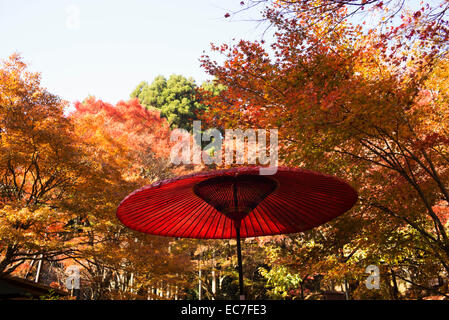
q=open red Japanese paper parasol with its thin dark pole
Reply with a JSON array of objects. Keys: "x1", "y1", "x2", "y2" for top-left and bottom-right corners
[{"x1": 117, "y1": 167, "x2": 357, "y2": 297}]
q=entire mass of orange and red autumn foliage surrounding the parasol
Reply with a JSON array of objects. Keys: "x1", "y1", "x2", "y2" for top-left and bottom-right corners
[{"x1": 0, "y1": 0, "x2": 449, "y2": 299}]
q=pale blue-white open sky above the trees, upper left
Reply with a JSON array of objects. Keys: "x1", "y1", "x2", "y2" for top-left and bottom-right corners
[{"x1": 0, "y1": 0, "x2": 263, "y2": 103}]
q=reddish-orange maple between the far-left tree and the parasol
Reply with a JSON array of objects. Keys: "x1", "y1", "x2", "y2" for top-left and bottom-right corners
[{"x1": 65, "y1": 97, "x2": 196, "y2": 299}]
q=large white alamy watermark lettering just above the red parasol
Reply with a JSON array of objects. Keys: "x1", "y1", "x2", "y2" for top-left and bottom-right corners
[{"x1": 170, "y1": 121, "x2": 279, "y2": 175}]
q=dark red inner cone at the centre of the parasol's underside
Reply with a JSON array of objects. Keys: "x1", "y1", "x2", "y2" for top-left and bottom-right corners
[{"x1": 193, "y1": 174, "x2": 278, "y2": 224}]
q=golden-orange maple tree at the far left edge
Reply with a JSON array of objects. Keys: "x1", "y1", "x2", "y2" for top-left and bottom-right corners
[{"x1": 0, "y1": 54, "x2": 89, "y2": 274}]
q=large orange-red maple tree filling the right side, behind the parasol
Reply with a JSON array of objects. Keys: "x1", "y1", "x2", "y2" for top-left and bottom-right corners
[{"x1": 202, "y1": 1, "x2": 449, "y2": 294}]
